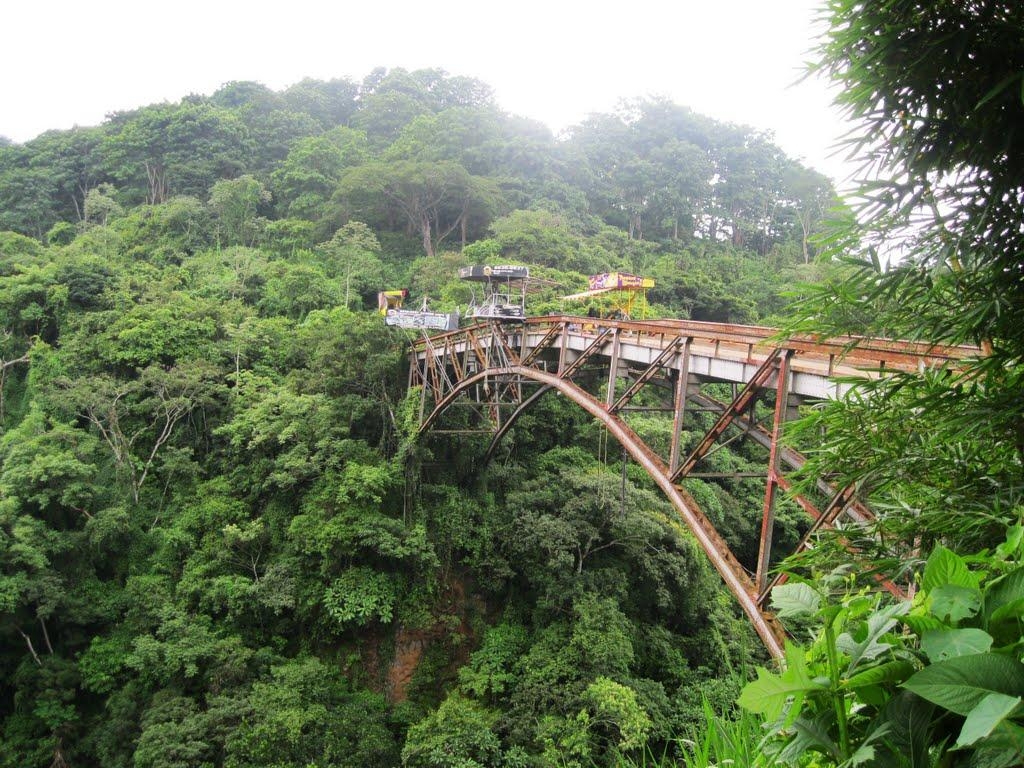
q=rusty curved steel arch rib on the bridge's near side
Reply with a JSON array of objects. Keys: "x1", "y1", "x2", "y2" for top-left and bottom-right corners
[{"x1": 421, "y1": 366, "x2": 785, "y2": 658}]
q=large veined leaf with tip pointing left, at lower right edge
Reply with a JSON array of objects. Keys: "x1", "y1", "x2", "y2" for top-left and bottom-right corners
[{"x1": 903, "y1": 653, "x2": 1024, "y2": 715}]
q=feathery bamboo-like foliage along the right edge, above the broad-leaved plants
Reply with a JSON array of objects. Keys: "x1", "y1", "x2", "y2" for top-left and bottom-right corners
[{"x1": 791, "y1": 2, "x2": 1024, "y2": 572}]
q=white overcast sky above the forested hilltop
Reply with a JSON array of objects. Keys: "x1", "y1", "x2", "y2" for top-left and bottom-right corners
[{"x1": 0, "y1": 0, "x2": 850, "y2": 181}]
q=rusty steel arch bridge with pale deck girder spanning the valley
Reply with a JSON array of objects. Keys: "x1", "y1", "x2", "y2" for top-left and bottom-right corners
[{"x1": 409, "y1": 315, "x2": 980, "y2": 658}]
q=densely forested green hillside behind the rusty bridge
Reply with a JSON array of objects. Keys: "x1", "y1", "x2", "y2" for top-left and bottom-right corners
[{"x1": 0, "y1": 70, "x2": 831, "y2": 768}]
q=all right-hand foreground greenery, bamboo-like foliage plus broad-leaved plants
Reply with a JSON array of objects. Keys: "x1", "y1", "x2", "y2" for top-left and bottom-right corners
[{"x1": 714, "y1": 0, "x2": 1024, "y2": 768}]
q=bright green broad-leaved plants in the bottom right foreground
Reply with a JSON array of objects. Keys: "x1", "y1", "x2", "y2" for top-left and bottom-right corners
[{"x1": 739, "y1": 525, "x2": 1024, "y2": 768}]
